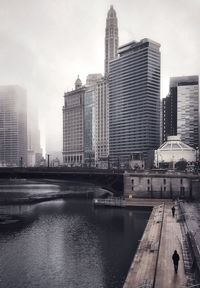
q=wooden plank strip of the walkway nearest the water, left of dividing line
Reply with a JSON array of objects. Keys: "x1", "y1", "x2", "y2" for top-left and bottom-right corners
[{"x1": 123, "y1": 204, "x2": 164, "y2": 288}]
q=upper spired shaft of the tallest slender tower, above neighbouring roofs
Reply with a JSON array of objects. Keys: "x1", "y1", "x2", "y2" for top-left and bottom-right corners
[{"x1": 104, "y1": 5, "x2": 119, "y2": 77}]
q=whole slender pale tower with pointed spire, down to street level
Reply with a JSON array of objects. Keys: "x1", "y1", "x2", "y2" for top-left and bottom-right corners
[{"x1": 95, "y1": 5, "x2": 119, "y2": 167}]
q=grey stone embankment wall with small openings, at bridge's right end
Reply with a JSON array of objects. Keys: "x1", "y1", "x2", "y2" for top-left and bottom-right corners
[{"x1": 124, "y1": 172, "x2": 200, "y2": 199}]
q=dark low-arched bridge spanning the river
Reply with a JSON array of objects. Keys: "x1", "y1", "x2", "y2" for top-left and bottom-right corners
[{"x1": 0, "y1": 167, "x2": 124, "y2": 196}]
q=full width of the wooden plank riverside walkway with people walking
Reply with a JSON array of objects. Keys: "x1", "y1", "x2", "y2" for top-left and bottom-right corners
[{"x1": 123, "y1": 200, "x2": 196, "y2": 288}]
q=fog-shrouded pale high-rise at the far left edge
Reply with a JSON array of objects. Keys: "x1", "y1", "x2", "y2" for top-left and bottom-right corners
[{"x1": 0, "y1": 85, "x2": 27, "y2": 166}]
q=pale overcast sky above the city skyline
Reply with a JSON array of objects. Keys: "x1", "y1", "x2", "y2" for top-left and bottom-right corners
[{"x1": 0, "y1": 0, "x2": 200, "y2": 151}]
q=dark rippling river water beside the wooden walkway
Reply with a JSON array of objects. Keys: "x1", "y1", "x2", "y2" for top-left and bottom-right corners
[{"x1": 0, "y1": 183, "x2": 150, "y2": 288}]
